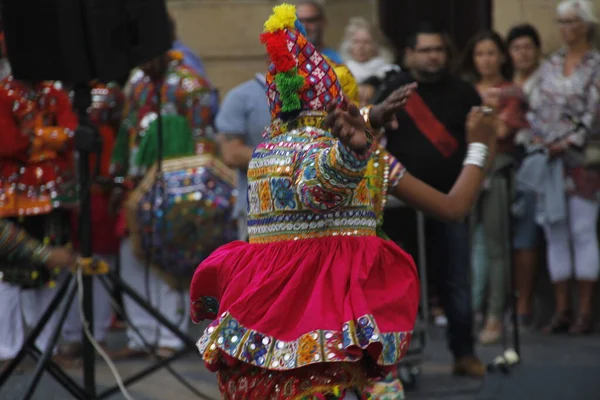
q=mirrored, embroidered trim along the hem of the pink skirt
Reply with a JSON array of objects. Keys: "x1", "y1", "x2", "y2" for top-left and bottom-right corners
[{"x1": 196, "y1": 312, "x2": 412, "y2": 371}]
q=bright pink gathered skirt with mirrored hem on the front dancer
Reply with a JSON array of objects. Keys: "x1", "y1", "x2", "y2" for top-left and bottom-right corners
[{"x1": 191, "y1": 236, "x2": 419, "y2": 371}]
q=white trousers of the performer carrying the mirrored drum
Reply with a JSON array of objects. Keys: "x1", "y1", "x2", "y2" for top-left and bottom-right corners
[{"x1": 121, "y1": 239, "x2": 190, "y2": 350}]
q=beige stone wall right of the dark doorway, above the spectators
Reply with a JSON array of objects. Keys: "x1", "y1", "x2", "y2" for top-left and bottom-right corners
[{"x1": 492, "y1": 0, "x2": 600, "y2": 54}]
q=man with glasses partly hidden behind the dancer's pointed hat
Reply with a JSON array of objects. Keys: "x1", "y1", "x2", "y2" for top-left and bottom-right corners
[{"x1": 296, "y1": 0, "x2": 343, "y2": 64}]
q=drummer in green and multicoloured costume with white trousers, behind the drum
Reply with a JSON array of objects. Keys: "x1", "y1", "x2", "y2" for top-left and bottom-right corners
[{"x1": 111, "y1": 51, "x2": 221, "y2": 358}]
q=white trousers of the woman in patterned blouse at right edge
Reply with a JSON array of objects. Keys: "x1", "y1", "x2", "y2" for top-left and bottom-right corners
[{"x1": 544, "y1": 196, "x2": 600, "y2": 282}]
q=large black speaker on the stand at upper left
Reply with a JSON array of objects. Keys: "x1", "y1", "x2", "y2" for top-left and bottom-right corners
[{"x1": 1, "y1": 0, "x2": 173, "y2": 83}]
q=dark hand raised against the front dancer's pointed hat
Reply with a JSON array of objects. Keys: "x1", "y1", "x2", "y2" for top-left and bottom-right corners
[{"x1": 325, "y1": 104, "x2": 369, "y2": 151}]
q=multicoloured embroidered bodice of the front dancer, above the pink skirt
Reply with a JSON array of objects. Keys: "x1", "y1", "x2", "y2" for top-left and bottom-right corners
[{"x1": 248, "y1": 115, "x2": 403, "y2": 243}]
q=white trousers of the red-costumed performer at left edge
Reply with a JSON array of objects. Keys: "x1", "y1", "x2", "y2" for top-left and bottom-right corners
[{"x1": 0, "y1": 282, "x2": 60, "y2": 360}]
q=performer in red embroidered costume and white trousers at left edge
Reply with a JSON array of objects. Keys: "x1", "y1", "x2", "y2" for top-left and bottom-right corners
[{"x1": 0, "y1": 76, "x2": 77, "y2": 359}]
